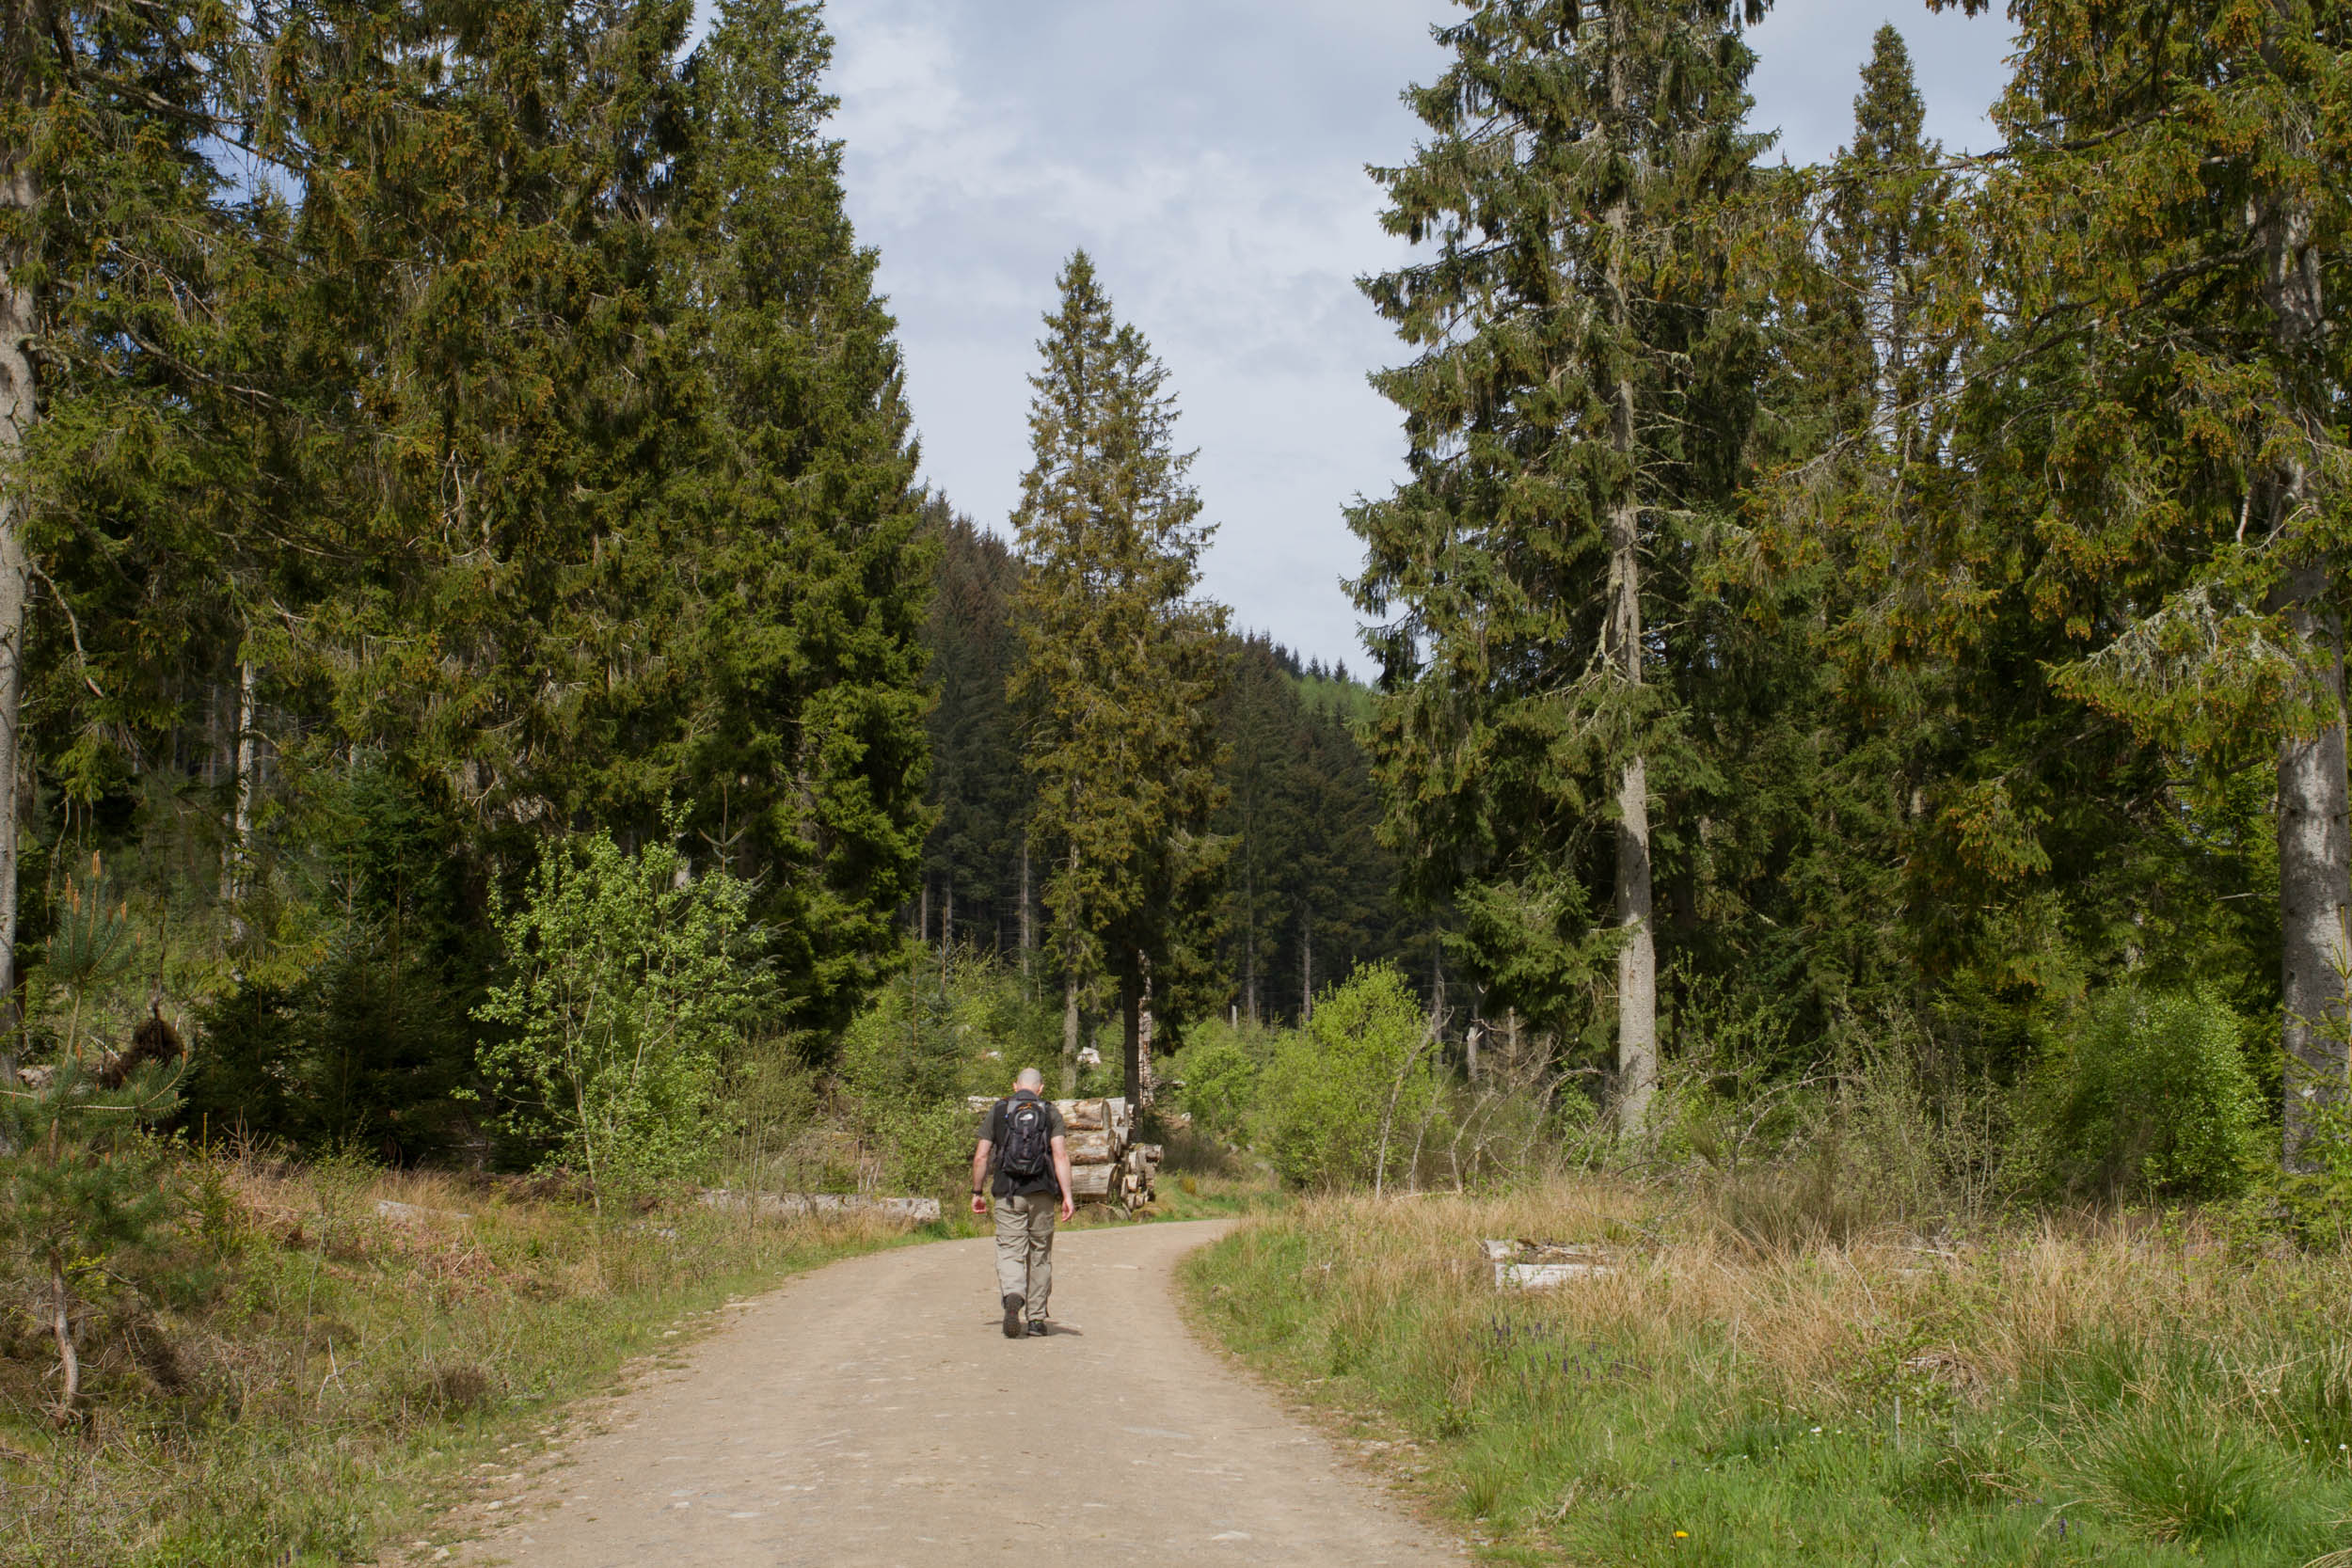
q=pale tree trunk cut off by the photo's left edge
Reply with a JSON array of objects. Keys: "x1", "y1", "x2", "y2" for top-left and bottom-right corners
[{"x1": 0, "y1": 169, "x2": 38, "y2": 1053}]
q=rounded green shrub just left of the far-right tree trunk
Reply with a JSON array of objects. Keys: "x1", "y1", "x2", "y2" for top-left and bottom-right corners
[{"x1": 2027, "y1": 985, "x2": 2263, "y2": 1196}]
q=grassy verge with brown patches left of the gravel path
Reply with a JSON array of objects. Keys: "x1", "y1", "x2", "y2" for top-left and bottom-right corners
[{"x1": 0, "y1": 1159, "x2": 946, "y2": 1568}]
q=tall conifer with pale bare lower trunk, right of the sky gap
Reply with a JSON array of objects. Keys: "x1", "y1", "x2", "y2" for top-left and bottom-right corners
[{"x1": 1350, "y1": 0, "x2": 1762, "y2": 1129}]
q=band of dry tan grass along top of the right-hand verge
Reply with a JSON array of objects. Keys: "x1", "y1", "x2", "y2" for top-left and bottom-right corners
[{"x1": 1296, "y1": 1180, "x2": 2352, "y2": 1402}]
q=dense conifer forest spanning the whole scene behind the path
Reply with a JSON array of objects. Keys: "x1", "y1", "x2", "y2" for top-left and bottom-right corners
[{"x1": 0, "y1": 0, "x2": 2352, "y2": 1222}]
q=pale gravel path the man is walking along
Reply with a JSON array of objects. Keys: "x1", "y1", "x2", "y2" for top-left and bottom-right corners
[{"x1": 459, "y1": 1225, "x2": 1463, "y2": 1568}]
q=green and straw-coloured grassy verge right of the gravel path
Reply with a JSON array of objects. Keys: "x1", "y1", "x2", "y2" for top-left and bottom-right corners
[{"x1": 1188, "y1": 1180, "x2": 2352, "y2": 1568}]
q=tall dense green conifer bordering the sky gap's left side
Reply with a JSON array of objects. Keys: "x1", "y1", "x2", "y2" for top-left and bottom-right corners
[{"x1": 668, "y1": 0, "x2": 936, "y2": 1032}]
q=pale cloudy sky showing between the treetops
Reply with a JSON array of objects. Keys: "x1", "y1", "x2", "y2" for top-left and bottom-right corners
[{"x1": 828, "y1": 0, "x2": 2009, "y2": 668}]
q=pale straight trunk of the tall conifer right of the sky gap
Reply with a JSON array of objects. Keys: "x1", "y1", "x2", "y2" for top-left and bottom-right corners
[{"x1": 1602, "y1": 18, "x2": 1659, "y2": 1133}]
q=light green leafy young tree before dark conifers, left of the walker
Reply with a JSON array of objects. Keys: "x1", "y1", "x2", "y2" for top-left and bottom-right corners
[{"x1": 475, "y1": 832, "x2": 755, "y2": 1201}]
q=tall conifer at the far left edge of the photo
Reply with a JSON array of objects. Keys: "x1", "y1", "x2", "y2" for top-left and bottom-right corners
[{"x1": 0, "y1": 2, "x2": 251, "y2": 1055}]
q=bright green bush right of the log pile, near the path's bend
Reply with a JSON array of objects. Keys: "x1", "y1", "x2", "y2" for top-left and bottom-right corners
[{"x1": 1259, "y1": 964, "x2": 1435, "y2": 1187}]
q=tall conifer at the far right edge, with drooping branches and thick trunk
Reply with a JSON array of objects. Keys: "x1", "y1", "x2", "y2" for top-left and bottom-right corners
[{"x1": 1929, "y1": 0, "x2": 2352, "y2": 1164}]
